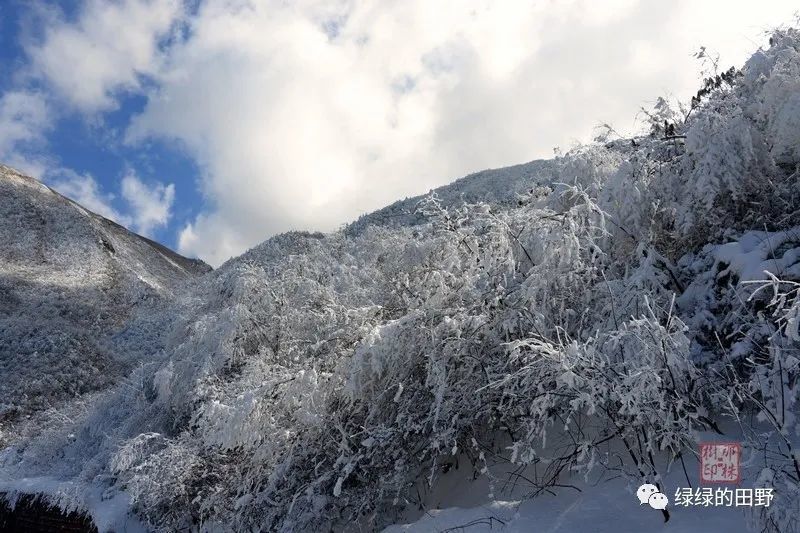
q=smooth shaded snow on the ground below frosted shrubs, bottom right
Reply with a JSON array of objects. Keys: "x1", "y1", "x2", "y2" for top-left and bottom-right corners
[{"x1": 383, "y1": 424, "x2": 764, "y2": 533}]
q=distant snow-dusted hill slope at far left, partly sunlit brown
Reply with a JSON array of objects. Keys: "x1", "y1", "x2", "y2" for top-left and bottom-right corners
[{"x1": 0, "y1": 166, "x2": 210, "y2": 444}]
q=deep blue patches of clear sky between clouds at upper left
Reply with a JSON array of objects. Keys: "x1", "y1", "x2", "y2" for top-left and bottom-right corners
[{"x1": 0, "y1": 0, "x2": 204, "y2": 248}]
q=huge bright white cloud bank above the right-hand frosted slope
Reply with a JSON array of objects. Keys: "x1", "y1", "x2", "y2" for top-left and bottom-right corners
[{"x1": 122, "y1": 0, "x2": 793, "y2": 264}]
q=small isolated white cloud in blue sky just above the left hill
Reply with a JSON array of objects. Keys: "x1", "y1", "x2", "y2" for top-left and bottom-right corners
[{"x1": 122, "y1": 172, "x2": 175, "y2": 235}]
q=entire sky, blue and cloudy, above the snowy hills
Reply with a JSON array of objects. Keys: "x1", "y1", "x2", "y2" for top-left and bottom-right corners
[{"x1": 0, "y1": 0, "x2": 796, "y2": 265}]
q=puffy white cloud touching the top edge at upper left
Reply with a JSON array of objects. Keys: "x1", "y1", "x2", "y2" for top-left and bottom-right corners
[{"x1": 27, "y1": 0, "x2": 182, "y2": 112}]
